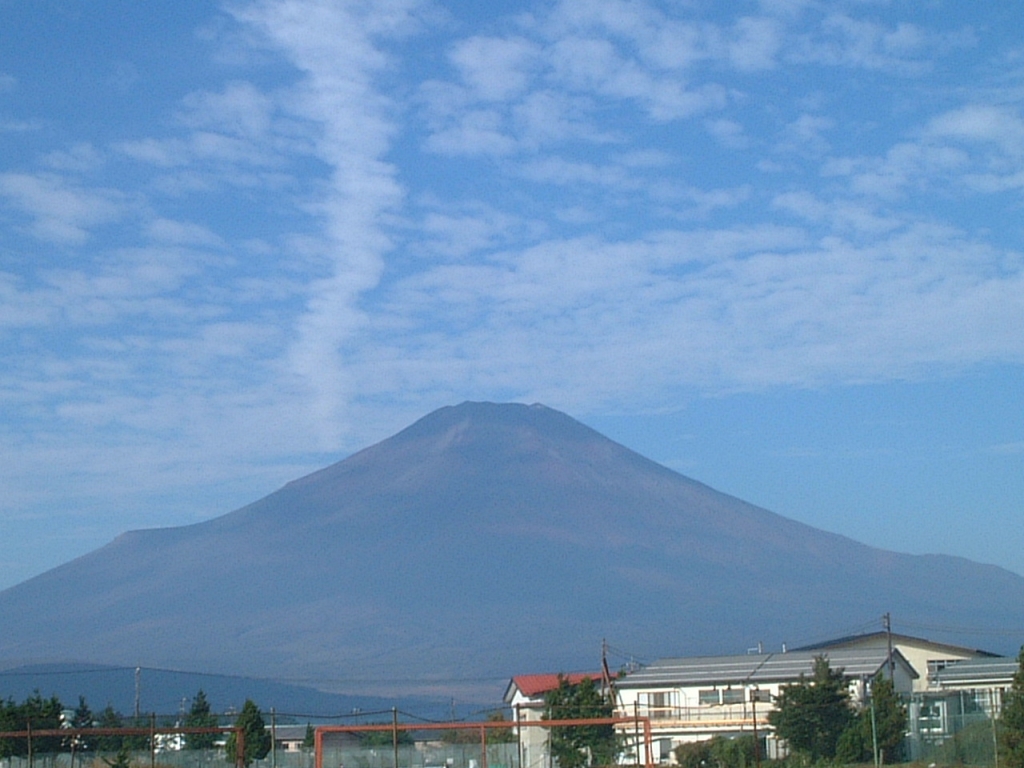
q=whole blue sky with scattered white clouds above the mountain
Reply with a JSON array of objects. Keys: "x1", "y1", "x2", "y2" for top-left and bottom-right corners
[{"x1": 0, "y1": 0, "x2": 1024, "y2": 602}]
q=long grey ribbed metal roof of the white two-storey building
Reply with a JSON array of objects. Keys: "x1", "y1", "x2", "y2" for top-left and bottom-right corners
[{"x1": 616, "y1": 648, "x2": 912, "y2": 688}]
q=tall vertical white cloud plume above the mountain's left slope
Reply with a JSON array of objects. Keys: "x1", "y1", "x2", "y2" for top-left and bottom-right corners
[{"x1": 236, "y1": 0, "x2": 413, "y2": 449}]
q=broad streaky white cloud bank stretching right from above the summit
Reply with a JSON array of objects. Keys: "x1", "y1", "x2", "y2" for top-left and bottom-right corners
[{"x1": 342, "y1": 214, "x2": 1024, "y2": 406}]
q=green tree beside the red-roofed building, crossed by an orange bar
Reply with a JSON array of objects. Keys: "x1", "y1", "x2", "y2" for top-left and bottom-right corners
[{"x1": 543, "y1": 675, "x2": 620, "y2": 768}]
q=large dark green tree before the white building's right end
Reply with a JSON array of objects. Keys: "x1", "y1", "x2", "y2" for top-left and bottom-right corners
[{"x1": 768, "y1": 656, "x2": 855, "y2": 762}]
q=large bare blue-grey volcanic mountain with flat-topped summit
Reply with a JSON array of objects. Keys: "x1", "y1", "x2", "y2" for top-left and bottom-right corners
[{"x1": 0, "y1": 402, "x2": 1024, "y2": 697}]
